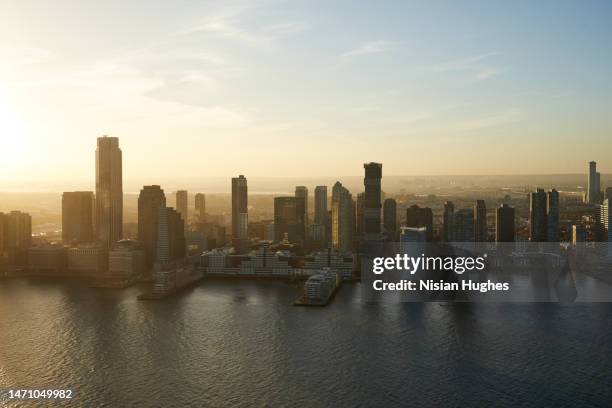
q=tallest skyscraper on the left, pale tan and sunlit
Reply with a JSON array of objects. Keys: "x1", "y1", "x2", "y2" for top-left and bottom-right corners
[{"x1": 95, "y1": 136, "x2": 123, "y2": 247}]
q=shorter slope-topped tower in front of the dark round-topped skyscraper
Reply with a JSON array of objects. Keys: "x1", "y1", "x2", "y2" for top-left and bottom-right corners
[{"x1": 156, "y1": 206, "x2": 185, "y2": 264}]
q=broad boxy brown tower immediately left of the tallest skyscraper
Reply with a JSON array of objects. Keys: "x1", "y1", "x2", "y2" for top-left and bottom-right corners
[{"x1": 62, "y1": 191, "x2": 95, "y2": 245}]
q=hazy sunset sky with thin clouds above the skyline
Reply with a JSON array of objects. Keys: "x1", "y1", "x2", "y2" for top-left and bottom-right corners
[{"x1": 0, "y1": 0, "x2": 612, "y2": 190}]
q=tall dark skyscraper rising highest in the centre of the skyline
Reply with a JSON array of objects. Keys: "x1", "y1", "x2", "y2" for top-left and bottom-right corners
[{"x1": 363, "y1": 162, "x2": 382, "y2": 241}]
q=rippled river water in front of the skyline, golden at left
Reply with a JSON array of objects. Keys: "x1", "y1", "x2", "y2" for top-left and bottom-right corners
[{"x1": 0, "y1": 280, "x2": 612, "y2": 407}]
